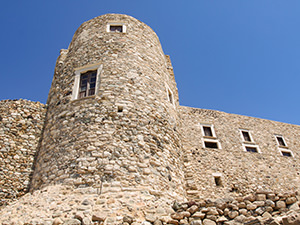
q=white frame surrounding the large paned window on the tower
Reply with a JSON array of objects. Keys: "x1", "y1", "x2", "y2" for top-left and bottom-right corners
[{"x1": 72, "y1": 63, "x2": 103, "y2": 100}]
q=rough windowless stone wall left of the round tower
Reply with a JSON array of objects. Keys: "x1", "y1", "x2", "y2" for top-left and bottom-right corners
[{"x1": 0, "y1": 100, "x2": 45, "y2": 206}]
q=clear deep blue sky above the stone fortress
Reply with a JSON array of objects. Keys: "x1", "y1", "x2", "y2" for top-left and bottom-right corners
[{"x1": 0, "y1": 0, "x2": 300, "y2": 124}]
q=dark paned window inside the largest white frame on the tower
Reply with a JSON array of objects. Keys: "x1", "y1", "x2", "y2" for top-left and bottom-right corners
[{"x1": 78, "y1": 70, "x2": 97, "y2": 98}]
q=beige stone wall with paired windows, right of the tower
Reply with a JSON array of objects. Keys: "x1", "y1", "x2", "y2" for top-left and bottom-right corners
[{"x1": 180, "y1": 106, "x2": 300, "y2": 198}]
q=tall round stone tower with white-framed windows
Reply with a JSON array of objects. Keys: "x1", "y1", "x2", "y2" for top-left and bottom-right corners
[{"x1": 31, "y1": 14, "x2": 184, "y2": 199}]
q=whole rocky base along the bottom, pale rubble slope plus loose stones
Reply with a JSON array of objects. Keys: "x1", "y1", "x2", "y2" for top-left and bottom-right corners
[{"x1": 0, "y1": 185, "x2": 300, "y2": 225}]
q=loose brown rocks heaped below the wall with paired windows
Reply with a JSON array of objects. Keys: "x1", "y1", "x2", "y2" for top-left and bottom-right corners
[{"x1": 162, "y1": 192, "x2": 300, "y2": 225}]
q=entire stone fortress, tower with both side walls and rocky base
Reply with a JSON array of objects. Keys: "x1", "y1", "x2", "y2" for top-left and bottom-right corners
[{"x1": 0, "y1": 14, "x2": 300, "y2": 225}]
